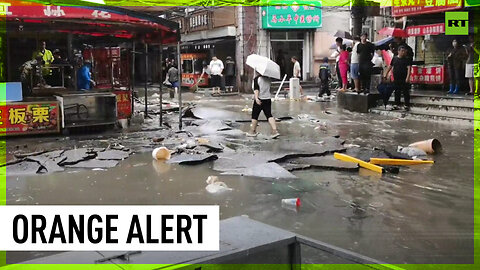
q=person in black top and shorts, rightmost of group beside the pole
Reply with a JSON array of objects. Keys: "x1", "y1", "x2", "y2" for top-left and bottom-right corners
[{"x1": 384, "y1": 46, "x2": 412, "y2": 111}]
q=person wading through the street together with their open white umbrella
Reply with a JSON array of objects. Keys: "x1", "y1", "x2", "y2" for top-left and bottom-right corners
[{"x1": 246, "y1": 54, "x2": 280, "y2": 139}]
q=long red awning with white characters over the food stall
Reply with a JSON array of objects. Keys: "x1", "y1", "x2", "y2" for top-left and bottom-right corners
[{"x1": 6, "y1": 6, "x2": 179, "y2": 44}]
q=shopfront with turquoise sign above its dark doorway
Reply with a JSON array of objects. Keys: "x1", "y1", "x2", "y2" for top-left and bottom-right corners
[{"x1": 261, "y1": 6, "x2": 322, "y2": 80}]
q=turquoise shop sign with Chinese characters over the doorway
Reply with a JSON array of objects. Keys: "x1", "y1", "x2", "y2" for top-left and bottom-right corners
[{"x1": 262, "y1": 6, "x2": 322, "y2": 29}]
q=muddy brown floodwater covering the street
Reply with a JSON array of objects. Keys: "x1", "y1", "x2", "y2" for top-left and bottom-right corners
[{"x1": 7, "y1": 93, "x2": 474, "y2": 264}]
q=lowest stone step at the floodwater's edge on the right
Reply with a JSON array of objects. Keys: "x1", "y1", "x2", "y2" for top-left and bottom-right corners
[{"x1": 370, "y1": 107, "x2": 476, "y2": 126}]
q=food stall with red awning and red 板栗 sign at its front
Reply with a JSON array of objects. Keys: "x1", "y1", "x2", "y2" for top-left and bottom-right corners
[{"x1": 0, "y1": 6, "x2": 179, "y2": 135}]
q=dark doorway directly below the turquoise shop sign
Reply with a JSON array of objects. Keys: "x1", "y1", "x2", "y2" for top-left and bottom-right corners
[{"x1": 270, "y1": 31, "x2": 304, "y2": 79}]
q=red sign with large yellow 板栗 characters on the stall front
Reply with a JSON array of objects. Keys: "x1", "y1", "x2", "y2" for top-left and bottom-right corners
[{"x1": 0, "y1": 102, "x2": 60, "y2": 136}]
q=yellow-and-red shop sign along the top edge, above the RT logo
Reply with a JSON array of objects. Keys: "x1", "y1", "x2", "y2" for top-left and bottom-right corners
[{"x1": 392, "y1": 0, "x2": 463, "y2": 17}]
